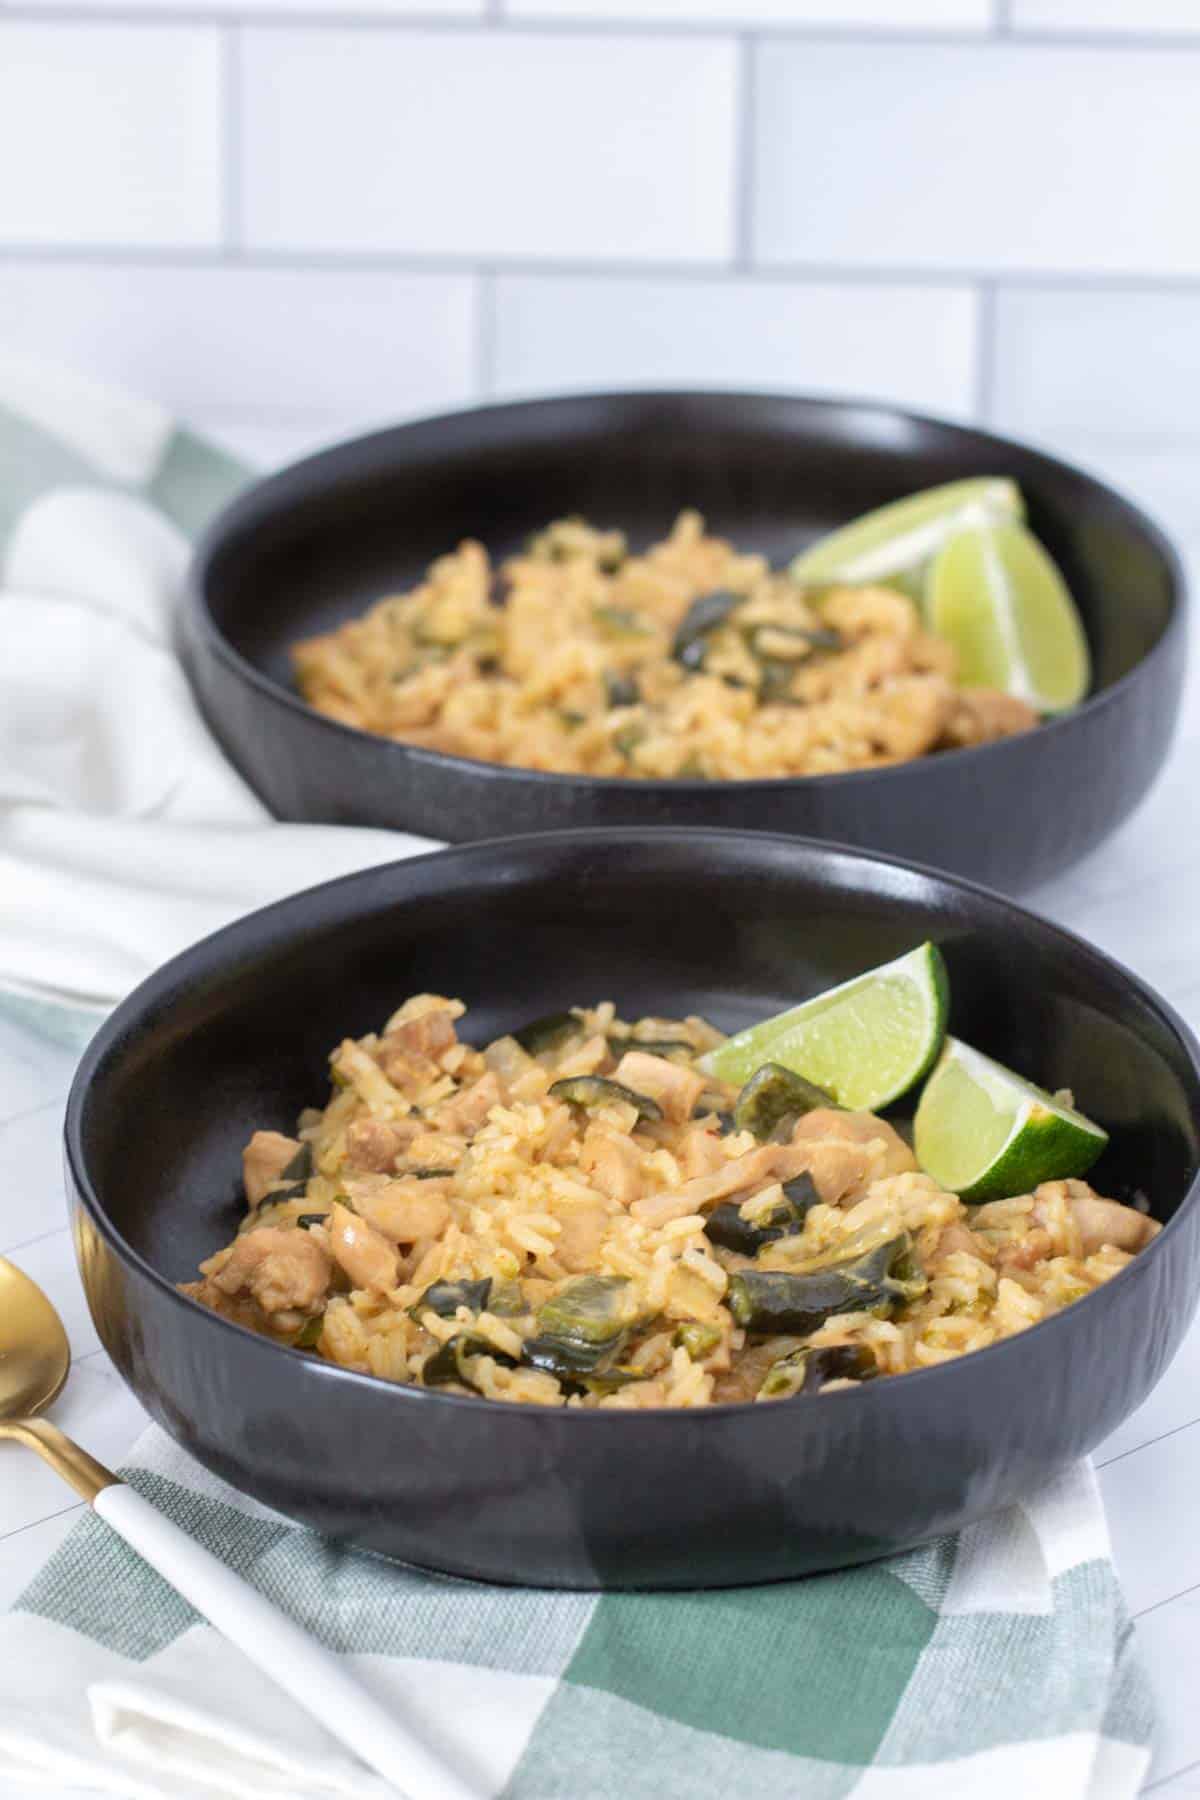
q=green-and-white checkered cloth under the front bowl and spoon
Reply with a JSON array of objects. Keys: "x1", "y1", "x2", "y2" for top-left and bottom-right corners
[{"x1": 0, "y1": 1425, "x2": 1150, "y2": 1800}]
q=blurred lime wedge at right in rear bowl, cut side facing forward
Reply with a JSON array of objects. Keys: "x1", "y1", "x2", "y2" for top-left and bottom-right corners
[{"x1": 925, "y1": 520, "x2": 1090, "y2": 713}]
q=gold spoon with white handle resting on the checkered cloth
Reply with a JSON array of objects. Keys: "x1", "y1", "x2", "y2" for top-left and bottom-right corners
[{"x1": 0, "y1": 1256, "x2": 477, "y2": 1800}]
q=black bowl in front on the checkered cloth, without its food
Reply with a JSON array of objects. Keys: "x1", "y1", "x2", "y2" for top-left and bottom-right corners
[{"x1": 67, "y1": 832, "x2": 1200, "y2": 1588}]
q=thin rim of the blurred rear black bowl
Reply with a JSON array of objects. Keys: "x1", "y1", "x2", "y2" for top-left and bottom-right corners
[{"x1": 185, "y1": 387, "x2": 1187, "y2": 797}]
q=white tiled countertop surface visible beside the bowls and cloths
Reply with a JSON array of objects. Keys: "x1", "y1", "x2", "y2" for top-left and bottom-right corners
[{"x1": 0, "y1": 522, "x2": 1200, "y2": 1796}]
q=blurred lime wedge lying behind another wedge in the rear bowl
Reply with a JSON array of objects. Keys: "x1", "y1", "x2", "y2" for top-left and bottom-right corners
[{"x1": 792, "y1": 475, "x2": 1025, "y2": 587}]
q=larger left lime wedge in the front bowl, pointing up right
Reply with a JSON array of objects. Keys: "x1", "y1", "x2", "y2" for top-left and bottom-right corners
[{"x1": 700, "y1": 943, "x2": 950, "y2": 1112}]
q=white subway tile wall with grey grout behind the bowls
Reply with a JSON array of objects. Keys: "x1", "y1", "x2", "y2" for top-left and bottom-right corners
[{"x1": 0, "y1": 10, "x2": 1200, "y2": 525}]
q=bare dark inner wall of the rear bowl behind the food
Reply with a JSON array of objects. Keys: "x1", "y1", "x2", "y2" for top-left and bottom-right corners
[{"x1": 200, "y1": 394, "x2": 1175, "y2": 705}]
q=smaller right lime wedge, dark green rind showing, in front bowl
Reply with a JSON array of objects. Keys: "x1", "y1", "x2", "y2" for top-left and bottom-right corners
[{"x1": 912, "y1": 1037, "x2": 1108, "y2": 1201}]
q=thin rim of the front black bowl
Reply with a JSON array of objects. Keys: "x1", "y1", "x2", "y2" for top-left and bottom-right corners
[{"x1": 63, "y1": 826, "x2": 1200, "y2": 1429}]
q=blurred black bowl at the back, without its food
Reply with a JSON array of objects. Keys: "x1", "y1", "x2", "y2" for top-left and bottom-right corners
[{"x1": 184, "y1": 394, "x2": 1184, "y2": 891}]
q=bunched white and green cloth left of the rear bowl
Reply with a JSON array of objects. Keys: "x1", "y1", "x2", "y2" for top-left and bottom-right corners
[{"x1": 0, "y1": 353, "x2": 432, "y2": 1033}]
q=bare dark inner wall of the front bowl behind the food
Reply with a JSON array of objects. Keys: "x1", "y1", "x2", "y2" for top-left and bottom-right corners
[{"x1": 77, "y1": 832, "x2": 1200, "y2": 1282}]
